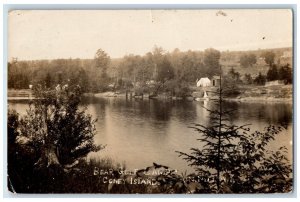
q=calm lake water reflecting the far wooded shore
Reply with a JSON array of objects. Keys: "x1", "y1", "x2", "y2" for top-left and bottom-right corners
[{"x1": 9, "y1": 97, "x2": 293, "y2": 172}]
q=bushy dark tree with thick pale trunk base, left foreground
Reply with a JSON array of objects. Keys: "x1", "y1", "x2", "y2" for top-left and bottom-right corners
[{"x1": 19, "y1": 86, "x2": 101, "y2": 169}]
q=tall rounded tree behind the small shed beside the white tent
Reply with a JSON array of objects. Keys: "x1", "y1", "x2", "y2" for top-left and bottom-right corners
[{"x1": 203, "y1": 48, "x2": 221, "y2": 75}]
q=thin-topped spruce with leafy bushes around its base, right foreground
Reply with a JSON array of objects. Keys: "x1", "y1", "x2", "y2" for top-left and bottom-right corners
[{"x1": 177, "y1": 74, "x2": 292, "y2": 193}]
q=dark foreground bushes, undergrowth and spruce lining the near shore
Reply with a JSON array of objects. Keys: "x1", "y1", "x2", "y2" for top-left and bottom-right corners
[{"x1": 7, "y1": 81, "x2": 293, "y2": 193}]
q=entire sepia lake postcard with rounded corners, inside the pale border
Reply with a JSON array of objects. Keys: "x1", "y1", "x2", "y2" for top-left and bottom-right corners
[{"x1": 5, "y1": 8, "x2": 295, "y2": 195}]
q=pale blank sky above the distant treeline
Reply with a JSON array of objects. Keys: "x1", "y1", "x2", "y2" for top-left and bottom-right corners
[{"x1": 8, "y1": 9, "x2": 293, "y2": 60}]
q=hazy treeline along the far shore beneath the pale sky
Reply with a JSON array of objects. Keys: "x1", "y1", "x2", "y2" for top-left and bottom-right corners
[{"x1": 8, "y1": 47, "x2": 291, "y2": 93}]
